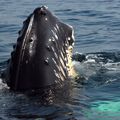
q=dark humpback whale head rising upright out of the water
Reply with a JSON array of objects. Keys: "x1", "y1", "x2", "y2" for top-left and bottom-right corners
[{"x1": 5, "y1": 6, "x2": 74, "y2": 91}]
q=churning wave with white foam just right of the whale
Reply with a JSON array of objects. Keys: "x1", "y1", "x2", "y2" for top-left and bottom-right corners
[{"x1": 72, "y1": 52, "x2": 120, "y2": 87}]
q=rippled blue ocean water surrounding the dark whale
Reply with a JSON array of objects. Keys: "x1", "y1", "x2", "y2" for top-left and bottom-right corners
[{"x1": 0, "y1": 0, "x2": 120, "y2": 120}]
